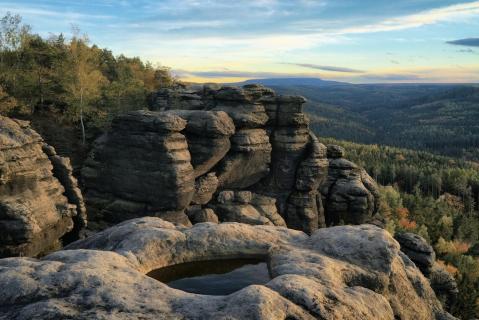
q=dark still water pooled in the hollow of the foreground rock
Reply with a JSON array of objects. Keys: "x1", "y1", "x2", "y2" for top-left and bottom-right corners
[{"x1": 147, "y1": 259, "x2": 271, "y2": 295}]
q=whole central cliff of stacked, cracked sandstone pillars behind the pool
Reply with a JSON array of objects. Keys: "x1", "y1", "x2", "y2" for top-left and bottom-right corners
[{"x1": 82, "y1": 85, "x2": 378, "y2": 232}]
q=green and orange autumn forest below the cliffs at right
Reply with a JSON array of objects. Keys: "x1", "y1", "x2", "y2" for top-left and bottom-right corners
[{"x1": 320, "y1": 137, "x2": 479, "y2": 319}]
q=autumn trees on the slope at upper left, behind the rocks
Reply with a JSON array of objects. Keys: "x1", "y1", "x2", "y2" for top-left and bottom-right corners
[{"x1": 0, "y1": 13, "x2": 175, "y2": 140}]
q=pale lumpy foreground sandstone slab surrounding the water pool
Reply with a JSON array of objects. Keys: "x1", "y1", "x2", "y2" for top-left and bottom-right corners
[{"x1": 0, "y1": 217, "x2": 454, "y2": 320}]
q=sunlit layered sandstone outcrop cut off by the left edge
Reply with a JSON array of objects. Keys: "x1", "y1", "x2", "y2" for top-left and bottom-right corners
[{"x1": 0, "y1": 116, "x2": 86, "y2": 257}]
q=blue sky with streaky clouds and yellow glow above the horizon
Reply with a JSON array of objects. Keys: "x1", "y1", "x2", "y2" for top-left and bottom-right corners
[{"x1": 0, "y1": 0, "x2": 479, "y2": 83}]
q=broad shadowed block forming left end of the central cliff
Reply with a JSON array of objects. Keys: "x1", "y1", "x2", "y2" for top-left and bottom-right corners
[{"x1": 82, "y1": 111, "x2": 195, "y2": 229}]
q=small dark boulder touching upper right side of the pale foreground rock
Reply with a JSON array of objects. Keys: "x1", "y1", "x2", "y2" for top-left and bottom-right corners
[{"x1": 394, "y1": 232, "x2": 436, "y2": 276}]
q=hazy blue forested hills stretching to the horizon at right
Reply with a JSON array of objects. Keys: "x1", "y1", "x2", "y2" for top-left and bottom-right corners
[{"x1": 246, "y1": 79, "x2": 479, "y2": 161}]
